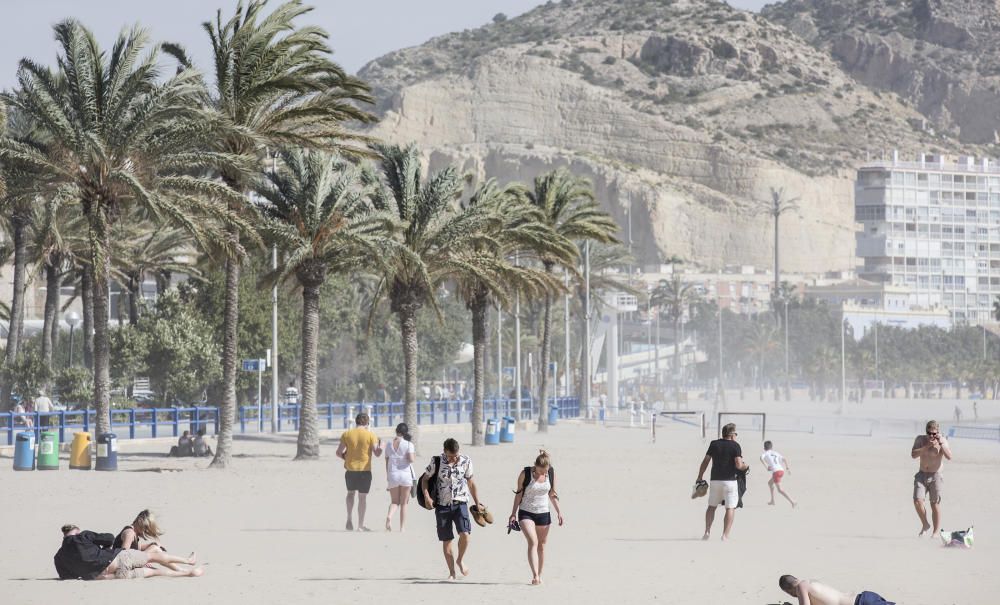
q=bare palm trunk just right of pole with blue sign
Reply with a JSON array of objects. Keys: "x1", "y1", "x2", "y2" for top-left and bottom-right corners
[{"x1": 295, "y1": 275, "x2": 323, "y2": 460}]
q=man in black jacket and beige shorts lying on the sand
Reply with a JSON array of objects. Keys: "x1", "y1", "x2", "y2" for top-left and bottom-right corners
[{"x1": 53, "y1": 525, "x2": 203, "y2": 580}]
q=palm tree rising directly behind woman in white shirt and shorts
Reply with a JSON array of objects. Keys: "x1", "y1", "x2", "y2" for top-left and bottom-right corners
[{"x1": 365, "y1": 144, "x2": 498, "y2": 442}]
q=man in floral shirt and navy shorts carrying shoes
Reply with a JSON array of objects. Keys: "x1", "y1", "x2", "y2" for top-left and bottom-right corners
[{"x1": 420, "y1": 438, "x2": 485, "y2": 580}]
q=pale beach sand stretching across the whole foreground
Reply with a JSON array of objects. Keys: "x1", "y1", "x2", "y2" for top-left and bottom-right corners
[{"x1": 0, "y1": 401, "x2": 1000, "y2": 605}]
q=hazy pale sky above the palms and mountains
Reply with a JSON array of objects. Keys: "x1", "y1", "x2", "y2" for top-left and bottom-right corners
[{"x1": 0, "y1": 0, "x2": 765, "y2": 88}]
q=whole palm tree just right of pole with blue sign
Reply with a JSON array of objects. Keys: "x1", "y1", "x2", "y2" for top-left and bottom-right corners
[{"x1": 255, "y1": 151, "x2": 395, "y2": 460}]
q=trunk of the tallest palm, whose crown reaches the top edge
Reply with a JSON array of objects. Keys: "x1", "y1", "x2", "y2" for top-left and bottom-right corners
[{"x1": 209, "y1": 249, "x2": 240, "y2": 468}]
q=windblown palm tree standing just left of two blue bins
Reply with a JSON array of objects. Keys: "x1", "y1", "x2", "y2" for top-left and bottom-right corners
[{"x1": 457, "y1": 180, "x2": 576, "y2": 445}]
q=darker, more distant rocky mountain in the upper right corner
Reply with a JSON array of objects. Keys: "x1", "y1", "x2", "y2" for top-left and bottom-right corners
[{"x1": 763, "y1": 0, "x2": 1000, "y2": 143}]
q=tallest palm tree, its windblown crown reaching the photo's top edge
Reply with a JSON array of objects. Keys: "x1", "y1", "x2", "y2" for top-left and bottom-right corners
[{"x1": 193, "y1": 0, "x2": 374, "y2": 468}]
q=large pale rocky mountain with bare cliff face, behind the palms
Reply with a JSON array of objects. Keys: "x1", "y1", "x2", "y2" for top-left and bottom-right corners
[{"x1": 360, "y1": 0, "x2": 974, "y2": 272}]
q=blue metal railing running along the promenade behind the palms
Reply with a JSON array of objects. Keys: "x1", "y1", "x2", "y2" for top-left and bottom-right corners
[{"x1": 0, "y1": 397, "x2": 580, "y2": 445}]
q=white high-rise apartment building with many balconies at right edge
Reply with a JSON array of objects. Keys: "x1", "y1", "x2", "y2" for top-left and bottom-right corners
[{"x1": 855, "y1": 154, "x2": 1000, "y2": 323}]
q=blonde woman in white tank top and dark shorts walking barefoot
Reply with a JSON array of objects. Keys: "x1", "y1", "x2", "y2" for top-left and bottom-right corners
[{"x1": 507, "y1": 450, "x2": 563, "y2": 586}]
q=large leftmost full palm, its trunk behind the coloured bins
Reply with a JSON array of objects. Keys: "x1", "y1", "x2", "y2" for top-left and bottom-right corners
[{"x1": 0, "y1": 20, "x2": 248, "y2": 433}]
